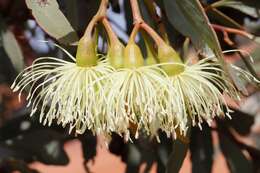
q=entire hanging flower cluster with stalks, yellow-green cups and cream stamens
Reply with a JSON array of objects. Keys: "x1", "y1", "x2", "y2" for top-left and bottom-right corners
[{"x1": 12, "y1": 1, "x2": 259, "y2": 140}]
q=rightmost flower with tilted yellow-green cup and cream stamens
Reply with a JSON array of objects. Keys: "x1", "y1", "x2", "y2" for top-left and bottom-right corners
[{"x1": 158, "y1": 45, "x2": 260, "y2": 134}]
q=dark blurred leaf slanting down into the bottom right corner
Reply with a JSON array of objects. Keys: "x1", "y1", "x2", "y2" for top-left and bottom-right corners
[{"x1": 219, "y1": 133, "x2": 253, "y2": 173}]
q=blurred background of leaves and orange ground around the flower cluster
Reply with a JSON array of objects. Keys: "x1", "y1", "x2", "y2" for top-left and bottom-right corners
[{"x1": 0, "y1": 0, "x2": 260, "y2": 173}]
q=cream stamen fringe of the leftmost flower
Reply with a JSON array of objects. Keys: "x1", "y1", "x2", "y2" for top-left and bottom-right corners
[{"x1": 12, "y1": 42, "x2": 114, "y2": 133}]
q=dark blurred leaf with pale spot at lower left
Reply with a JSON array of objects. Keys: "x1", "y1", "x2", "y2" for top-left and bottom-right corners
[{"x1": 0, "y1": 129, "x2": 69, "y2": 165}]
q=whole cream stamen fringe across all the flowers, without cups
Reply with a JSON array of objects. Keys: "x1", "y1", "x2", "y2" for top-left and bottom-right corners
[{"x1": 12, "y1": 47, "x2": 259, "y2": 139}]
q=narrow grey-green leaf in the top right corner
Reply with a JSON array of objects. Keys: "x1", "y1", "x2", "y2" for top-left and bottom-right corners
[{"x1": 213, "y1": 0, "x2": 260, "y2": 18}]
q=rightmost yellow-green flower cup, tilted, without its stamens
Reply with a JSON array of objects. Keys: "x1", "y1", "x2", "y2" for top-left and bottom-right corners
[{"x1": 158, "y1": 44, "x2": 184, "y2": 76}]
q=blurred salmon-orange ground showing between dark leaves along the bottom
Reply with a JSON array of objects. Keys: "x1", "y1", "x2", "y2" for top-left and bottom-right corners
[{"x1": 31, "y1": 140, "x2": 229, "y2": 173}]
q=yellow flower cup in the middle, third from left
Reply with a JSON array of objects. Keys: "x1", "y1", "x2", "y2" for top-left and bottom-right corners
[{"x1": 124, "y1": 42, "x2": 144, "y2": 68}]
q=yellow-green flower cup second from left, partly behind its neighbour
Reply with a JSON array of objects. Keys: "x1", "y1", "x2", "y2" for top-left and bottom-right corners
[{"x1": 108, "y1": 41, "x2": 125, "y2": 68}]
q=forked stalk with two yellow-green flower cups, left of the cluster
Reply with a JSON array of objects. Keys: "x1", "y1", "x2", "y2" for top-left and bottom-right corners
[{"x1": 76, "y1": 0, "x2": 123, "y2": 68}]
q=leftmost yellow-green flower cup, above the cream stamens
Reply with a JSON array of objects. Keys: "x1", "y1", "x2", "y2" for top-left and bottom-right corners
[{"x1": 76, "y1": 37, "x2": 98, "y2": 67}]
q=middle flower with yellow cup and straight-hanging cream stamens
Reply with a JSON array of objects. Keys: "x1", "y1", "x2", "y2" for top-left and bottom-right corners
[{"x1": 106, "y1": 44, "x2": 180, "y2": 139}]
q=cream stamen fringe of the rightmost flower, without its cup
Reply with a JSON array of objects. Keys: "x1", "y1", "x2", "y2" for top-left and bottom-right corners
[{"x1": 171, "y1": 58, "x2": 239, "y2": 130}]
